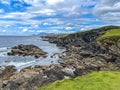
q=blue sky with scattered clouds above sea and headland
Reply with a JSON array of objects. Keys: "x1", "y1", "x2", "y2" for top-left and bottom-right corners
[{"x1": 0, "y1": 0, "x2": 120, "y2": 35}]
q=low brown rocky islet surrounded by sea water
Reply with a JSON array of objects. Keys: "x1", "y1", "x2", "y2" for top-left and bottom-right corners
[{"x1": 8, "y1": 44, "x2": 47, "y2": 58}]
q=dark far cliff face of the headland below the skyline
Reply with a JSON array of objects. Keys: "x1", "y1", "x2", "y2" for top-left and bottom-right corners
[{"x1": 45, "y1": 26, "x2": 119, "y2": 47}]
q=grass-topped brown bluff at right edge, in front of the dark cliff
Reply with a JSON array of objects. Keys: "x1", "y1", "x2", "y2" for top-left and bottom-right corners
[{"x1": 98, "y1": 29, "x2": 120, "y2": 56}]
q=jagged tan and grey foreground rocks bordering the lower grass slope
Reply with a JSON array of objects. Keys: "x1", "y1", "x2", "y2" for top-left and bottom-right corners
[{"x1": 0, "y1": 65, "x2": 73, "y2": 90}]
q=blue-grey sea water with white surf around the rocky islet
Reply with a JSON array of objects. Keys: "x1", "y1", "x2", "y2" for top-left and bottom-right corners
[{"x1": 0, "y1": 36, "x2": 65, "y2": 70}]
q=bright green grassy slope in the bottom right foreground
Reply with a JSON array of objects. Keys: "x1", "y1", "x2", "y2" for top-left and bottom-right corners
[{"x1": 38, "y1": 71, "x2": 120, "y2": 90}]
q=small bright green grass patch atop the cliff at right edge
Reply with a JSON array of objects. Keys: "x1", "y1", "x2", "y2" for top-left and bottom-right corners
[{"x1": 101, "y1": 29, "x2": 120, "y2": 39}]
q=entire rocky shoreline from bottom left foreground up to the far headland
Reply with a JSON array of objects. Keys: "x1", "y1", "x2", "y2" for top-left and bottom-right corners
[{"x1": 0, "y1": 26, "x2": 120, "y2": 90}]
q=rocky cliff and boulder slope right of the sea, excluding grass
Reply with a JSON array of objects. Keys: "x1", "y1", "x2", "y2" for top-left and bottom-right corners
[{"x1": 44, "y1": 26, "x2": 120, "y2": 76}]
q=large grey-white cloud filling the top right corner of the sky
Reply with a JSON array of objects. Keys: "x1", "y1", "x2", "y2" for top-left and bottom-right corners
[{"x1": 93, "y1": 0, "x2": 120, "y2": 23}]
